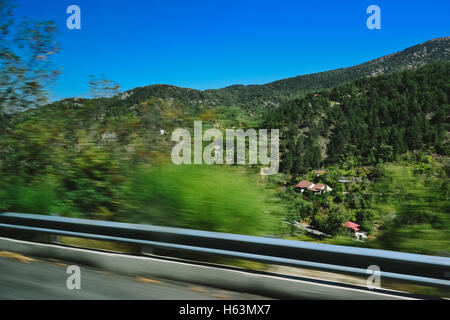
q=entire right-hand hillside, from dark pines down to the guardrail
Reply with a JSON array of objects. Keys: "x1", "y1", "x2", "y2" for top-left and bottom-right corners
[{"x1": 264, "y1": 63, "x2": 450, "y2": 254}]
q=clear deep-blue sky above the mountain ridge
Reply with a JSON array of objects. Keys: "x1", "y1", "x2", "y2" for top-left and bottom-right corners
[{"x1": 18, "y1": 0, "x2": 450, "y2": 98}]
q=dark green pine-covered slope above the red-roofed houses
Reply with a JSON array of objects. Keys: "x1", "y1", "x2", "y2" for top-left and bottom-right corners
[{"x1": 264, "y1": 63, "x2": 450, "y2": 173}]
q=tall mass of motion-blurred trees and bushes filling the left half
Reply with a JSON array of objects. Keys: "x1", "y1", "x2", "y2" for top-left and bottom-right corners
[{"x1": 0, "y1": 94, "x2": 281, "y2": 234}]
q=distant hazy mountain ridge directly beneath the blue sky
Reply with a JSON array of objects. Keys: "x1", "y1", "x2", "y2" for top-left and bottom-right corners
[{"x1": 115, "y1": 37, "x2": 450, "y2": 108}]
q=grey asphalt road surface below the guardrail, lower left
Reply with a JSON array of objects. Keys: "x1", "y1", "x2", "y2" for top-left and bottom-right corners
[{"x1": 0, "y1": 255, "x2": 265, "y2": 300}]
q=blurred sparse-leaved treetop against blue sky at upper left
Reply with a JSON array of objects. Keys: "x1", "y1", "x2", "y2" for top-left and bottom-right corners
[{"x1": 0, "y1": 0, "x2": 60, "y2": 117}]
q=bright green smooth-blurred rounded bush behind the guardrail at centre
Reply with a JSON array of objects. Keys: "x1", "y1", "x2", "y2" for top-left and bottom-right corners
[{"x1": 121, "y1": 165, "x2": 280, "y2": 235}]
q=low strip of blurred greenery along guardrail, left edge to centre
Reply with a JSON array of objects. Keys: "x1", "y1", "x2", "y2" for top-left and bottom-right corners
[{"x1": 0, "y1": 152, "x2": 281, "y2": 235}]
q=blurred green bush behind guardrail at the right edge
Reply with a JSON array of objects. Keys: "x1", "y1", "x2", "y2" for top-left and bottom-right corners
[{"x1": 374, "y1": 162, "x2": 450, "y2": 255}]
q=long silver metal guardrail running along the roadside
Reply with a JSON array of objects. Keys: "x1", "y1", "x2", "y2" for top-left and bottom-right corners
[{"x1": 0, "y1": 213, "x2": 450, "y2": 289}]
